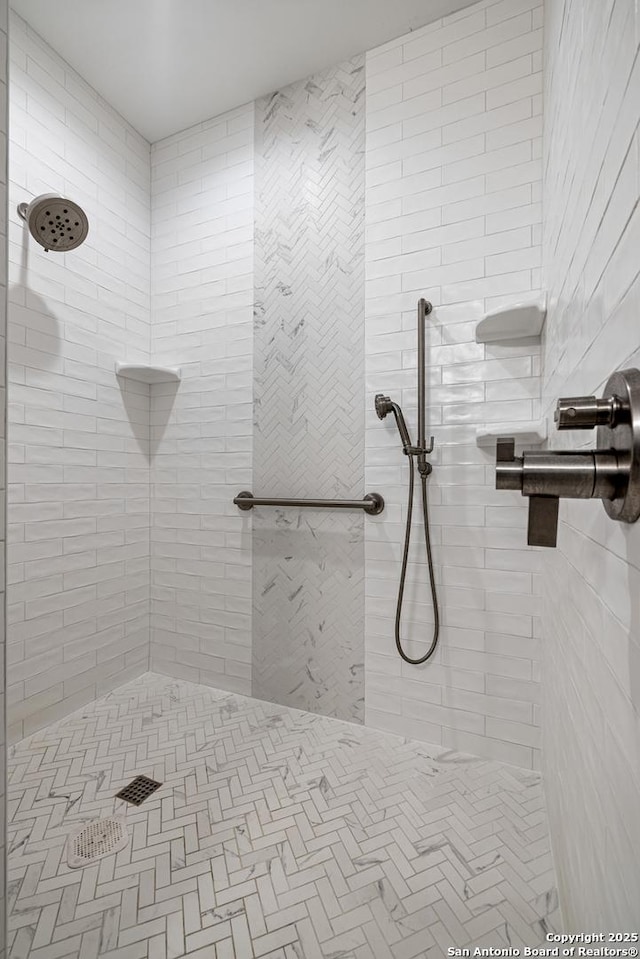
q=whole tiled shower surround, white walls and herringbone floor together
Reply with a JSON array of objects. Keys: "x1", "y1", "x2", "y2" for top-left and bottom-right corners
[{"x1": 0, "y1": 0, "x2": 640, "y2": 959}]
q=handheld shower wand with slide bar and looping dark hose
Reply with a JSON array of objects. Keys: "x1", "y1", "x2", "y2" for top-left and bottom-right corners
[{"x1": 375, "y1": 299, "x2": 440, "y2": 666}]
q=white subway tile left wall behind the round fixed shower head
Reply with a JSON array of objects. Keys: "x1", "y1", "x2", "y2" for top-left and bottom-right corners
[{"x1": 7, "y1": 15, "x2": 150, "y2": 739}]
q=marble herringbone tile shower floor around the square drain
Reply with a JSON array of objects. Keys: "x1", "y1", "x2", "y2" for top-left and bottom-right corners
[{"x1": 9, "y1": 674, "x2": 558, "y2": 959}]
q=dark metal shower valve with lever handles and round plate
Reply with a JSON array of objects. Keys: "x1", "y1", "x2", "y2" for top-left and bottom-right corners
[{"x1": 496, "y1": 369, "x2": 640, "y2": 546}]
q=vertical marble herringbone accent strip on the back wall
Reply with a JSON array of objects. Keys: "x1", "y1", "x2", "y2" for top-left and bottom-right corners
[{"x1": 253, "y1": 56, "x2": 365, "y2": 722}]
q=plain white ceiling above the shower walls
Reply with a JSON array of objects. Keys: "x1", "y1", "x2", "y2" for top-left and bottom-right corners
[{"x1": 13, "y1": 0, "x2": 473, "y2": 142}]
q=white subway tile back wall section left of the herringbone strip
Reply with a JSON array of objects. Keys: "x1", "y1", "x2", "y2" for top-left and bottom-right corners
[{"x1": 151, "y1": 104, "x2": 254, "y2": 694}]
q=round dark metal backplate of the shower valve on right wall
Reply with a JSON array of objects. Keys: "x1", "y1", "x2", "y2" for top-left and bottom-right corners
[{"x1": 597, "y1": 369, "x2": 640, "y2": 523}]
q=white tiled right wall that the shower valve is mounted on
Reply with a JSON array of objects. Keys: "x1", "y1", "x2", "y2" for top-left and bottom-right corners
[{"x1": 543, "y1": 0, "x2": 640, "y2": 932}]
